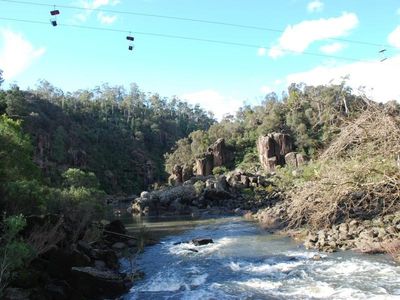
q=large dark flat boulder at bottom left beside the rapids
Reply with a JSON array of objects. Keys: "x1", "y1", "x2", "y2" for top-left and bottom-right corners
[{"x1": 72, "y1": 267, "x2": 130, "y2": 299}]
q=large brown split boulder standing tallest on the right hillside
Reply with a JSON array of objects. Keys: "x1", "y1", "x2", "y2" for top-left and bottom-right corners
[{"x1": 257, "y1": 133, "x2": 293, "y2": 172}]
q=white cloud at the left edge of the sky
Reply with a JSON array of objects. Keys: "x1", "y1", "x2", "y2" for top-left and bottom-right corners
[{"x1": 0, "y1": 29, "x2": 46, "y2": 80}]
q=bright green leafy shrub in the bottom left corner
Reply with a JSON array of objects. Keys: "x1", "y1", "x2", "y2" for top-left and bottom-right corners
[{"x1": 0, "y1": 215, "x2": 33, "y2": 297}]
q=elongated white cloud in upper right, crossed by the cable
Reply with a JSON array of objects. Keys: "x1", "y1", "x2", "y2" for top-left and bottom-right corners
[{"x1": 268, "y1": 12, "x2": 358, "y2": 58}]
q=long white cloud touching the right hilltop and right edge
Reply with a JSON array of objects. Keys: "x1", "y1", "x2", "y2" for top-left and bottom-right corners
[{"x1": 286, "y1": 55, "x2": 400, "y2": 102}]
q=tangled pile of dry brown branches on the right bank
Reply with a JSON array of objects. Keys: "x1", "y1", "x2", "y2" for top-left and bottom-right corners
[{"x1": 287, "y1": 107, "x2": 400, "y2": 229}]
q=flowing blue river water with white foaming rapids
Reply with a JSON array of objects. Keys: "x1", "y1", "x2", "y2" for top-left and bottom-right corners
[{"x1": 123, "y1": 217, "x2": 400, "y2": 300}]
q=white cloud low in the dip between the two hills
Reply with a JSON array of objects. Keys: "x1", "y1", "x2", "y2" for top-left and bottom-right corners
[{"x1": 180, "y1": 89, "x2": 242, "y2": 120}]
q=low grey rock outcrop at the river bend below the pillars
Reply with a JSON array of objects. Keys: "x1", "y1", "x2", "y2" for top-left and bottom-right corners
[{"x1": 128, "y1": 171, "x2": 275, "y2": 216}]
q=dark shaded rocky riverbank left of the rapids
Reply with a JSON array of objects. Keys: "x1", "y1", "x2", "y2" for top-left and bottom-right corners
[{"x1": 4, "y1": 215, "x2": 142, "y2": 300}]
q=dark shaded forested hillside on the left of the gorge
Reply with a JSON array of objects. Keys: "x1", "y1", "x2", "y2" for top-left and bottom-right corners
[{"x1": 0, "y1": 81, "x2": 214, "y2": 194}]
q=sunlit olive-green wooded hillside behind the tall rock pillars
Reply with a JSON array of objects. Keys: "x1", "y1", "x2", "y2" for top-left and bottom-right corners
[{"x1": 166, "y1": 82, "x2": 369, "y2": 173}]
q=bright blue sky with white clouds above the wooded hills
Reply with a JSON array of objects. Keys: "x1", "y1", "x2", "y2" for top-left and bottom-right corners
[{"x1": 0, "y1": 0, "x2": 400, "y2": 117}]
